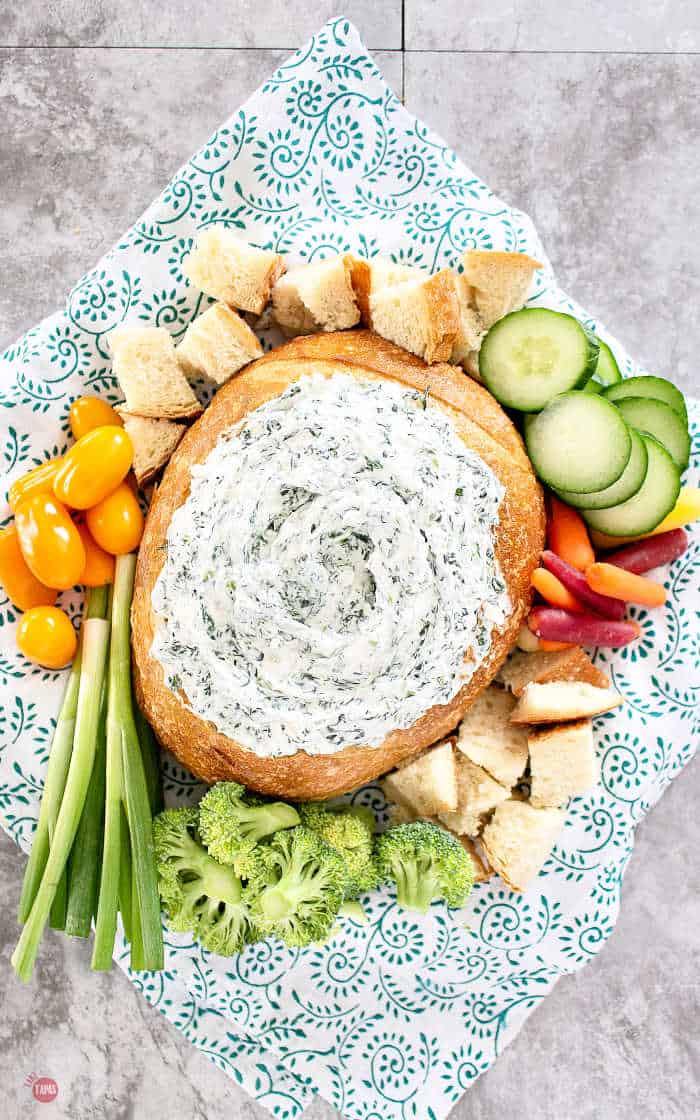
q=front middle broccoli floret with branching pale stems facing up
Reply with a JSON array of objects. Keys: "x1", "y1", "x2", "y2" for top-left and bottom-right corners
[{"x1": 245, "y1": 827, "x2": 347, "y2": 946}]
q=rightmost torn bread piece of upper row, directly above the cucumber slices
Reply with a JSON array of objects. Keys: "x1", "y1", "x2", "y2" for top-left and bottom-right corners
[{"x1": 461, "y1": 249, "x2": 542, "y2": 330}]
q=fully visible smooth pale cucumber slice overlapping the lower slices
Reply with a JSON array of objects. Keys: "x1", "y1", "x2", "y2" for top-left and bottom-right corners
[{"x1": 525, "y1": 392, "x2": 632, "y2": 494}]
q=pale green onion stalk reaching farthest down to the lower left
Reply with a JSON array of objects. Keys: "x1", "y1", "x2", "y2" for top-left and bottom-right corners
[{"x1": 12, "y1": 618, "x2": 110, "y2": 980}]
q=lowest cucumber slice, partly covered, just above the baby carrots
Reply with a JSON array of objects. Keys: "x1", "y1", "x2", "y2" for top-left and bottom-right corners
[{"x1": 582, "y1": 432, "x2": 681, "y2": 536}]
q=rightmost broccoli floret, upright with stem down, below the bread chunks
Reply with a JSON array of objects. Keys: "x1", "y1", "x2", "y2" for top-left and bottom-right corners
[{"x1": 375, "y1": 821, "x2": 474, "y2": 914}]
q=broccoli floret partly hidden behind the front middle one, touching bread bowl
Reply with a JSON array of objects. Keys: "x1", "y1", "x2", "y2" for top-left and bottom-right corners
[{"x1": 299, "y1": 802, "x2": 379, "y2": 898}]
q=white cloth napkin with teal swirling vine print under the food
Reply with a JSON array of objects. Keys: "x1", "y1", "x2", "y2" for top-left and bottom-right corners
[{"x1": 0, "y1": 19, "x2": 700, "y2": 1120}]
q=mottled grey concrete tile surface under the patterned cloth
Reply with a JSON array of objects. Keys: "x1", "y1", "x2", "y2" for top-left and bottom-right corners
[{"x1": 0, "y1": 0, "x2": 700, "y2": 1120}]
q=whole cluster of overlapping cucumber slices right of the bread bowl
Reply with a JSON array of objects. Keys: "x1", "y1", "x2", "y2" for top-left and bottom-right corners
[{"x1": 479, "y1": 308, "x2": 690, "y2": 536}]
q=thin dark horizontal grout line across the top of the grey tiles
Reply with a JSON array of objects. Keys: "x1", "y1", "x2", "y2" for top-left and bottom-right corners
[{"x1": 0, "y1": 44, "x2": 700, "y2": 58}]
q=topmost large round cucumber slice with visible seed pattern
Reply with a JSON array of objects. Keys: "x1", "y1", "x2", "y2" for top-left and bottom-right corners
[{"x1": 479, "y1": 307, "x2": 598, "y2": 412}]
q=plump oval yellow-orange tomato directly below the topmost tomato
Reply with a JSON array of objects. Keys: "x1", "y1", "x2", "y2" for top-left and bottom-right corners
[{"x1": 54, "y1": 424, "x2": 133, "y2": 510}]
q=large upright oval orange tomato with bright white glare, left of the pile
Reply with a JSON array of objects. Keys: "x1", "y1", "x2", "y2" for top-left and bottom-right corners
[{"x1": 15, "y1": 494, "x2": 85, "y2": 591}]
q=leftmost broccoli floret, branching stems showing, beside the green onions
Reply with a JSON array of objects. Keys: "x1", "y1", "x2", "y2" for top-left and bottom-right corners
[{"x1": 153, "y1": 809, "x2": 256, "y2": 956}]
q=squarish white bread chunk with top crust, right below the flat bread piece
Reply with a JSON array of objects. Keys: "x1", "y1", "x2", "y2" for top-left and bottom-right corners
[{"x1": 528, "y1": 719, "x2": 600, "y2": 809}]
